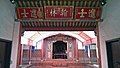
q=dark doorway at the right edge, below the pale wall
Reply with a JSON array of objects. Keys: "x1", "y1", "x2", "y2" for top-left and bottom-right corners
[{"x1": 106, "y1": 39, "x2": 120, "y2": 68}]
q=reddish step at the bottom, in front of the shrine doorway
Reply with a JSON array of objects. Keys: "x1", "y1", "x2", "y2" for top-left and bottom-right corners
[{"x1": 22, "y1": 60, "x2": 98, "y2": 68}]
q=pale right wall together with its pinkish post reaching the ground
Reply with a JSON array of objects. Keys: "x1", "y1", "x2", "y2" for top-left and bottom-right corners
[{"x1": 99, "y1": 0, "x2": 120, "y2": 68}]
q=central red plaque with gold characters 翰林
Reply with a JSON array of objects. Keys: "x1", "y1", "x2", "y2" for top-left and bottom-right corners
[{"x1": 44, "y1": 6, "x2": 74, "y2": 19}]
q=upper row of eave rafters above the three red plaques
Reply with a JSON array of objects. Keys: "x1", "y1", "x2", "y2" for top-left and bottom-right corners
[{"x1": 16, "y1": 0, "x2": 101, "y2": 7}]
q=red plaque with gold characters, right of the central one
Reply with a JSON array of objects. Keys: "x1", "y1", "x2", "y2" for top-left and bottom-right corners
[{"x1": 75, "y1": 7, "x2": 101, "y2": 20}]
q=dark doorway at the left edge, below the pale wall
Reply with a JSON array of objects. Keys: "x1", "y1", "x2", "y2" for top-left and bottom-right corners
[{"x1": 0, "y1": 39, "x2": 12, "y2": 68}]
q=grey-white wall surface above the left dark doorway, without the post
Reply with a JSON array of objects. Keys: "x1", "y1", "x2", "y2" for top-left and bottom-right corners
[{"x1": 0, "y1": 0, "x2": 15, "y2": 40}]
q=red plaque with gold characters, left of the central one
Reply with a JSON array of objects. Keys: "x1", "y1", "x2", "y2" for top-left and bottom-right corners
[{"x1": 17, "y1": 7, "x2": 43, "y2": 20}]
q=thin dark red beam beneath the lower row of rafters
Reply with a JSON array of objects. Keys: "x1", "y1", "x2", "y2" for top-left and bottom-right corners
[{"x1": 24, "y1": 27, "x2": 95, "y2": 31}]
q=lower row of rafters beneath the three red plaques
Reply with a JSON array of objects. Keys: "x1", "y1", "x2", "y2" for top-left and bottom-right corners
[{"x1": 21, "y1": 21, "x2": 98, "y2": 31}]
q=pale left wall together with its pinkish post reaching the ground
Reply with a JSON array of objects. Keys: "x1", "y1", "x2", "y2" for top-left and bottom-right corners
[{"x1": 0, "y1": 0, "x2": 19, "y2": 68}]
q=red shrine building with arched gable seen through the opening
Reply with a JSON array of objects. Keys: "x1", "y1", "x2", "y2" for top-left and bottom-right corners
[{"x1": 21, "y1": 33, "x2": 98, "y2": 68}]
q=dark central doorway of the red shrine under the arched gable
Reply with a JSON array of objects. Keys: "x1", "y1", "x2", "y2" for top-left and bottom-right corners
[{"x1": 52, "y1": 41, "x2": 67, "y2": 59}]
